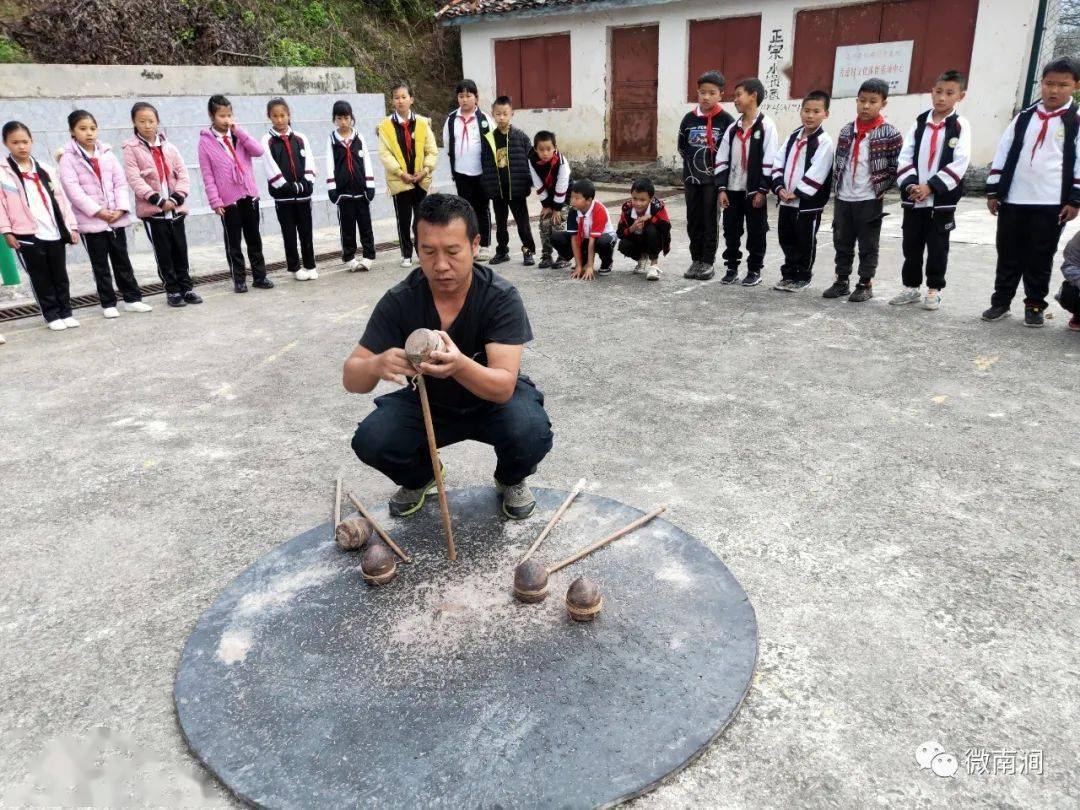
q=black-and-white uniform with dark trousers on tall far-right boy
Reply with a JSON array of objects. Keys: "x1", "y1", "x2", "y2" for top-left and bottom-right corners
[{"x1": 986, "y1": 102, "x2": 1080, "y2": 310}]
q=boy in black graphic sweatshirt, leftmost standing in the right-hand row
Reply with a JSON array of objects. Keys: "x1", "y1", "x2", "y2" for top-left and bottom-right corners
[{"x1": 678, "y1": 70, "x2": 734, "y2": 281}]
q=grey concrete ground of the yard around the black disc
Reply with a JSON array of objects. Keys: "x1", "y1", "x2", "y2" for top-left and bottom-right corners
[{"x1": 0, "y1": 193, "x2": 1080, "y2": 809}]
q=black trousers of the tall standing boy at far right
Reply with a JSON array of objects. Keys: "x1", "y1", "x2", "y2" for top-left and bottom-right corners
[{"x1": 990, "y1": 203, "x2": 1064, "y2": 309}]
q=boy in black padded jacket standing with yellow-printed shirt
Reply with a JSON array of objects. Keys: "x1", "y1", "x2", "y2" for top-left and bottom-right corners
[{"x1": 481, "y1": 96, "x2": 537, "y2": 266}]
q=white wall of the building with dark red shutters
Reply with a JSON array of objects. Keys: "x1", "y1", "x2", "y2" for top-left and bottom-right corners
[{"x1": 461, "y1": 0, "x2": 1038, "y2": 165}]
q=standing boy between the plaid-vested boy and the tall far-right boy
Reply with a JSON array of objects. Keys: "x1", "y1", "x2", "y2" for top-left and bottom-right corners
[{"x1": 889, "y1": 70, "x2": 971, "y2": 310}]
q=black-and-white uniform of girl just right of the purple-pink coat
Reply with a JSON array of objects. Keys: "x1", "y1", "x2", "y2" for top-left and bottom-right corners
[{"x1": 262, "y1": 127, "x2": 315, "y2": 273}]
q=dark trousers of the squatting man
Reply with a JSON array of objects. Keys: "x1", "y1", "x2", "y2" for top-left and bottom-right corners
[{"x1": 352, "y1": 377, "x2": 553, "y2": 489}]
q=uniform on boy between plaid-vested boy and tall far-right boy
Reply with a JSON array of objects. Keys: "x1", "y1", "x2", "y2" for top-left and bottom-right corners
[{"x1": 896, "y1": 110, "x2": 971, "y2": 289}]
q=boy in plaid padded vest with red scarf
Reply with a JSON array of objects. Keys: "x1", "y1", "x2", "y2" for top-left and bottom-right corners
[{"x1": 823, "y1": 79, "x2": 904, "y2": 302}]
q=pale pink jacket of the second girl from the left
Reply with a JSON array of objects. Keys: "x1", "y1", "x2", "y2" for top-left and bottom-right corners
[{"x1": 60, "y1": 138, "x2": 132, "y2": 233}]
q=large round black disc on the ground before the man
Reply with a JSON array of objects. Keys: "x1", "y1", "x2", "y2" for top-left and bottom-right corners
[{"x1": 175, "y1": 488, "x2": 757, "y2": 808}]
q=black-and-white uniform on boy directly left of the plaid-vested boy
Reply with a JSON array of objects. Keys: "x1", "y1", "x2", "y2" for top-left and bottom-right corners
[{"x1": 772, "y1": 126, "x2": 836, "y2": 281}]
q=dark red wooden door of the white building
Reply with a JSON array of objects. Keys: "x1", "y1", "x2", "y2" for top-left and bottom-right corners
[{"x1": 608, "y1": 25, "x2": 660, "y2": 161}]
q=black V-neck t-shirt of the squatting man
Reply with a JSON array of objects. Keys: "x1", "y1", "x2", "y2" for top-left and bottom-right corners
[{"x1": 360, "y1": 265, "x2": 532, "y2": 409}]
